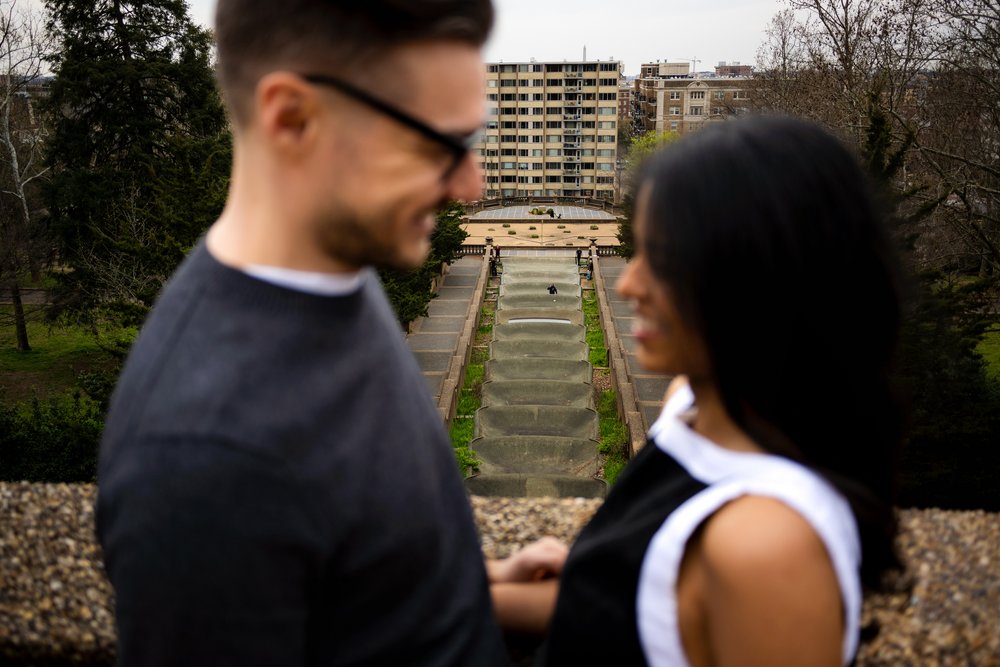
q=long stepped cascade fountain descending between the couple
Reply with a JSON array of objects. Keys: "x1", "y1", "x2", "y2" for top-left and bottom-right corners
[{"x1": 466, "y1": 257, "x2": 606, "y2": 497}]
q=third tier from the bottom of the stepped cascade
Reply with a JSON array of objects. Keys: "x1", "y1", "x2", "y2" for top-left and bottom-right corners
[{"x1": 475, "y1": 405, "x2": 599, "y2": 440}]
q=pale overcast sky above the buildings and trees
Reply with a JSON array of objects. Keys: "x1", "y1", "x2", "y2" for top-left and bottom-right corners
[{"x1": 188, "y1": 0, "x2": 780, "y2": 75}]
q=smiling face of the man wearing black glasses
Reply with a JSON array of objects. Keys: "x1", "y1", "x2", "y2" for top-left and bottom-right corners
[{"x1": 311, "y1": 42, "x2": 485, "y2": 269}]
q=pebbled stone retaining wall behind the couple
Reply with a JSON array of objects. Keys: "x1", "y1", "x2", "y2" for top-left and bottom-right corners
[{"x1": 0, "y1": 483, "x2": 1000, "y2": 667}]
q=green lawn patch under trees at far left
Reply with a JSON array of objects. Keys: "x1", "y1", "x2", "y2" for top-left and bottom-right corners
[{"x1": 0, "y1": 306, "x2": 115, "y2": 404}]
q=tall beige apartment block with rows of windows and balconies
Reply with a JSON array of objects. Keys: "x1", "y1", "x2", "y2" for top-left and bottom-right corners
[{"x1": 475, "y1": 61, "x2": 621, "y2": 199}]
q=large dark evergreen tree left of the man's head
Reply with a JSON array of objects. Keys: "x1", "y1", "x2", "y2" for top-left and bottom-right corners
[{"x1": 46, "y1": 0, "x2": 232, "y2": 336}]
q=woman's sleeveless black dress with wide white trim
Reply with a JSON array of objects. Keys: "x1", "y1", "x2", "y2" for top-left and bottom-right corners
[{"x1": 539, "y1": 388, "x2": 861, "y2": 667}]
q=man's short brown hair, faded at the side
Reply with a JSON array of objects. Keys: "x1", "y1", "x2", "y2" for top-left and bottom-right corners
[{"x1": 215, "y1": 0, "x2": 493, "y2": 124}]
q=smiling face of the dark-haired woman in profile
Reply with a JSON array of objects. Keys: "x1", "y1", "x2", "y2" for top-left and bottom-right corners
[{"x1": 616, "y1": 186, "x2": 709, "y2": 379}]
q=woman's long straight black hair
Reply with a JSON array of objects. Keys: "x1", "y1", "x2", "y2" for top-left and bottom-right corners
[{"x1": 637, "y1": 117, "x2": 902, "y2": 587}]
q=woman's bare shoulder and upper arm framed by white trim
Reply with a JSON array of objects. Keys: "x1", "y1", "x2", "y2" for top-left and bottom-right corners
[{"x1": 678, "y1": 496, "x2": 844, "y2": 667}]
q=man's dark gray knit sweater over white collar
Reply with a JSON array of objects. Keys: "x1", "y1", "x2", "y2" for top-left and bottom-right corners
[{"x1": 97, "y1": 245, "x2": 506, "y2": 667}]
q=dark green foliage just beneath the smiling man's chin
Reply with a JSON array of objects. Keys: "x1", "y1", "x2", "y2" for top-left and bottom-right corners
[{"x1": 379, "y1": 202, "x2": 469, "y2": 329}]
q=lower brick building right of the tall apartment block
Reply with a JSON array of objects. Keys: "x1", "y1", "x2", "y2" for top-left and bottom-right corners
[{"x1": 633, "y1": 63, "x2": 750, "y2": 134}]
